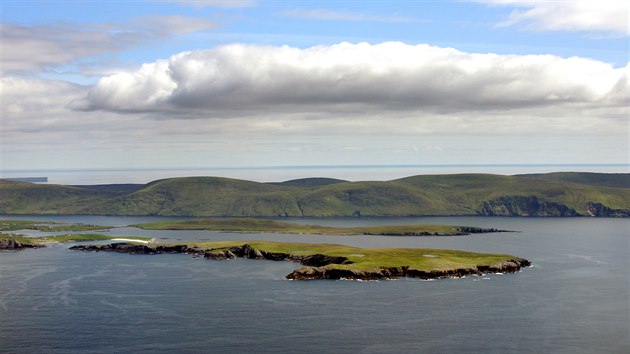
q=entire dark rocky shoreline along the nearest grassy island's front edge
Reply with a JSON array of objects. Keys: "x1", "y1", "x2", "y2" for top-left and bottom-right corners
[{"x1": 70, "y1": 243, "x2": 531, "y2": 280}]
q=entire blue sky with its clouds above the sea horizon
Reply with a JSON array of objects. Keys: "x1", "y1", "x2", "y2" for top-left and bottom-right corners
[{"x1": 0, "y1": 0, "x2": 630, "y2": 181}]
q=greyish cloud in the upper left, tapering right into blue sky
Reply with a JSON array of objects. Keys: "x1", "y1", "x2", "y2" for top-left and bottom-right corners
[{"x1": 0, "y1": 16, "x2": 215, "y2": 75}]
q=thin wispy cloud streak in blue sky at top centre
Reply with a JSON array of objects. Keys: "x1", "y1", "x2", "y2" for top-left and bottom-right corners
[{"x1": 283, "y1": 9, "x2": 420, "y2": 23}]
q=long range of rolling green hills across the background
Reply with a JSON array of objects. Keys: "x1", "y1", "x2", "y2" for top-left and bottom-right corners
[{"x1": 0, "y1": 173, "x2": 630, "y2": 216}]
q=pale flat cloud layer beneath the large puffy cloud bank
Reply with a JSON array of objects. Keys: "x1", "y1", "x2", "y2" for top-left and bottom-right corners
[{"x1": 0, "y1": 73, "x2": 628, "y2": 171}]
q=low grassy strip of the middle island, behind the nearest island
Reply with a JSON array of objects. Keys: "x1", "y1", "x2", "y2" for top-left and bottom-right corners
[{"x1": 131, "y1": 218, "x2": 488, "y2": 236}]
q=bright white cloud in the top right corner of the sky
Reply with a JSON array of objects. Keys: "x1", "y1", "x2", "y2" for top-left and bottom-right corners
[{"x1": 478, "y1": 0, "x2": 630, "y2": 35}]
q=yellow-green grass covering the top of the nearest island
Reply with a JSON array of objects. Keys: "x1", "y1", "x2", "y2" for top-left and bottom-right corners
[{"x1": 189, "y1": 241, "x2": 516, "y2": 271}]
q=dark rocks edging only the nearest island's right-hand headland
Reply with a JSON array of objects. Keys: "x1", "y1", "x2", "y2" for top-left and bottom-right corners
[{"x1": 286, "y1": 258, "x2": 531, "y2": 280}]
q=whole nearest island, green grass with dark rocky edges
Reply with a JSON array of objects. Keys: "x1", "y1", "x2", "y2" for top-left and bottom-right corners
[{"x1": 70, "y1": 241, "x2": 531, "y2": 280}]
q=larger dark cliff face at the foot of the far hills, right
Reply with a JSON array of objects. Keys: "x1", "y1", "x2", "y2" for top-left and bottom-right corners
[{"x1": 478, "y1": 196, "x2": 579, "y2": 216}]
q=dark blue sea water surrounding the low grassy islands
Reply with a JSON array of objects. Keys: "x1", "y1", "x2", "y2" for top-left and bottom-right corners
[{"x1": 0, "y1": 217, "x2": 630, "y2": 353}]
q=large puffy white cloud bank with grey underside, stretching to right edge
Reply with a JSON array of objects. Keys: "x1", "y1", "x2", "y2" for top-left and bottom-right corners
[{"x1": 79, "y1": 42, "x2": 630, "y2": 118}]
